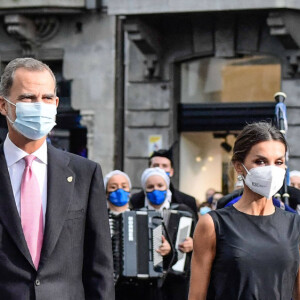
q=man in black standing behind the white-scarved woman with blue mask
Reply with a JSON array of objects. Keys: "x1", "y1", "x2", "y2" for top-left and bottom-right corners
[{"x1": 130, "y1": 148, "x2": 198, "y2": 300}]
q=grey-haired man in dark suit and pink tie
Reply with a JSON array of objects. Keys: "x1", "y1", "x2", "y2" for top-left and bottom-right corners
[{"x1": 0, "y1": 58, "x2": 114, "y2": 300}]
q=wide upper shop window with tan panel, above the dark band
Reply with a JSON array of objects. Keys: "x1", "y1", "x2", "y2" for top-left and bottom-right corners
[{"x1": 181, "y1": 56, "x2": 281, "y2": 103}]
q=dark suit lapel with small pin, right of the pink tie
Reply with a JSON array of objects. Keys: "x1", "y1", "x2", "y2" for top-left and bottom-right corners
[{"x1": 40, "y1": 145, "x2": 75, "y2": 267}]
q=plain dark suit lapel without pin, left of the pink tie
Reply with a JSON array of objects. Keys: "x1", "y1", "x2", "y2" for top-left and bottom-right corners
[{"x1": 0, "y1": 144, "x2": 34, "y2": 267}]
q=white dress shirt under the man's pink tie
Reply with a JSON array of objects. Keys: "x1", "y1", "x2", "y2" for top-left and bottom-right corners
[{"x1": 3, "y1": 135, "x2": 47, "y2": 228}]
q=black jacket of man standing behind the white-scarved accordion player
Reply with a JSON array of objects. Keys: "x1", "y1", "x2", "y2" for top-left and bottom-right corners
[{"x1": 130, "y1": 183, "x2": 198, "y2": 220}]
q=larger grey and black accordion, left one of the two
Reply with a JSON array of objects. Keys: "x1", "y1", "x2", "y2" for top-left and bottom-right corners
[{"x1": 110, "y1": 211, "x2": 163, "y2": 280}]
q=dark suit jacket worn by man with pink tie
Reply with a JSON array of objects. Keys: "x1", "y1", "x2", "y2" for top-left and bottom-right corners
[{"x1": 0, "y1": 145, "x2": 114, "y2": 300}]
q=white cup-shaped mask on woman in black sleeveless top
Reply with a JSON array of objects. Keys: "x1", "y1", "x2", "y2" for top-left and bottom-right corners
[{"x1": 242, "y1": 164, "x2": 285, "y2": 199}]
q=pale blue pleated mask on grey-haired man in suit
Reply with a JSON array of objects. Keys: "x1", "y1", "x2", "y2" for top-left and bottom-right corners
[{"x1": 4, "y1": 98, "x2": 57, "y2": 140}]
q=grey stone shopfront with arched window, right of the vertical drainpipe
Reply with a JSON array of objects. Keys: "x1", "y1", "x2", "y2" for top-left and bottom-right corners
[{"x1": 108, "y1": 0, "x2": 300, "y2": 201}]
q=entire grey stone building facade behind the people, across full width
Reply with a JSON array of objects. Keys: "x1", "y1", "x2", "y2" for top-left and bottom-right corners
[{"x1": 0, "y1": 0, "x2": 300, "y2": 200}]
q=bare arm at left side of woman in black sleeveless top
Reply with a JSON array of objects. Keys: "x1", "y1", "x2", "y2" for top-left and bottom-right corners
[{"x1": 189, "y1": 214, "x2": 216, "y2": 300}]
